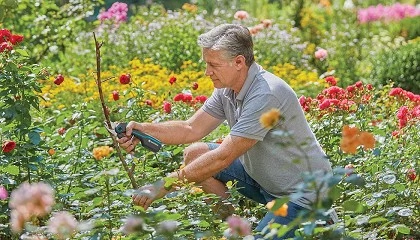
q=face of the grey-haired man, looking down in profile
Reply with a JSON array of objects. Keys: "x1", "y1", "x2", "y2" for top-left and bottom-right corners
[{"x1": 203, "y1": 49, "x2": 239, "y2": 89}]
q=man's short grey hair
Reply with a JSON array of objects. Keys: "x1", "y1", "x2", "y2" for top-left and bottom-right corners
[{"x1": 197, "y1": 24, "x2": 254, "y2": 66}]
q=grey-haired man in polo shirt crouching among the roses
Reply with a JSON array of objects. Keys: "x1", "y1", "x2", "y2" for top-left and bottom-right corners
[{"x1": 119, "y1": 24, "x2": 331, "y2": 237}]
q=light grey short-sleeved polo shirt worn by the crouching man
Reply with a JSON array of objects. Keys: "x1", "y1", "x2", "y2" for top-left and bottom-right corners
[{"x1": 203, "y1": 63, "x2": 331, "y2": 208}]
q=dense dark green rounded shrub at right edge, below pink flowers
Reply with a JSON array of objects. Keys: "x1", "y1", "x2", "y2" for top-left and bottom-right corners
[{"x1": 370, "y1": 40, "x2": 420, "y2": 93}]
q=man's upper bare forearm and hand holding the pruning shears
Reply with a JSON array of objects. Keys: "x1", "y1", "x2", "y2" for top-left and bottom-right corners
[{"x1": 118, "y1": 109, "x2": 223, "y2": 152}]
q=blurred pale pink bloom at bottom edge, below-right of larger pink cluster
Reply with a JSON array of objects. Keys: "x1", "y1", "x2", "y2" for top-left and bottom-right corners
[{"x1": 48, "y1": 211, "x2": 78, "y2": 239}]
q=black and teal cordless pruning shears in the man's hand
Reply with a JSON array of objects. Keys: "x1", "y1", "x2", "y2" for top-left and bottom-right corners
[{"x1": 104, "y1": 122, "x2": 162, "y2": 152}]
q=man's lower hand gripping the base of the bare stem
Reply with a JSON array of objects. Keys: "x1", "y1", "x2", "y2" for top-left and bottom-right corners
[{"x1": 131, "y1": 180, "x2": 169, "y2": 210}]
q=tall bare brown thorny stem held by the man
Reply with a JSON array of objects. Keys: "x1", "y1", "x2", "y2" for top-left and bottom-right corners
[{"x1": 93, "y1": 33, "x2": 138, "y2": 189}]
